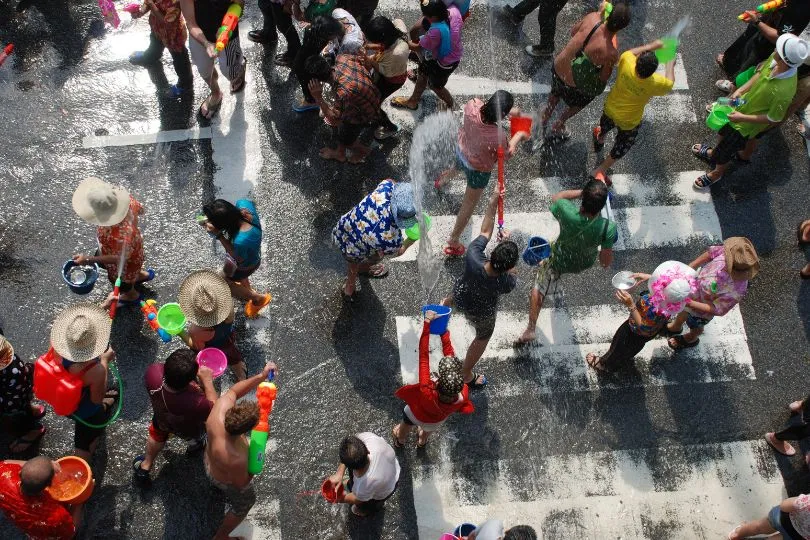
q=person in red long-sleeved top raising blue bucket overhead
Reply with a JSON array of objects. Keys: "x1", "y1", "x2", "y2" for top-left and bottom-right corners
[{"x1": 391, "y1": 311, "x2": 475, "y2": 448}]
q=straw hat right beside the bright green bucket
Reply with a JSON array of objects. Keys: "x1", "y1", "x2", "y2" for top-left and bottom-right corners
[{"x1": 177, "y1": 270, "x2": 233, "y2": 328}]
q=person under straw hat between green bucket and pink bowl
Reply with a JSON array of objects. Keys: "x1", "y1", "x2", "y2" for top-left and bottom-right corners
[{"x1": 177, "y1": 270, "x2": 246, "y2": 381}]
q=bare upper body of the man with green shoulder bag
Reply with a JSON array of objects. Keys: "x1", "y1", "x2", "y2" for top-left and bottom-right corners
[{"x1": 554, "y1": 12, "x2": 619, "y2": 86}]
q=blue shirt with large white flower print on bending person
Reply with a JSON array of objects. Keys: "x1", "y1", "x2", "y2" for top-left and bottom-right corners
[{"x1": 332, "y1": 180, "x2": 403, "y2": 262}]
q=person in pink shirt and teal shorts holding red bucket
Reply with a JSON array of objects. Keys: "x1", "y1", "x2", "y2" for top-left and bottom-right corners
[{"x1": 435, "y1": 90, "x2": 529, "y2": 257}]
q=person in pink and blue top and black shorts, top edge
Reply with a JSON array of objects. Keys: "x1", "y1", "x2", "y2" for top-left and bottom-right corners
[{"x1": 391, "y1": 0, "x2": 464, "y2": 111}]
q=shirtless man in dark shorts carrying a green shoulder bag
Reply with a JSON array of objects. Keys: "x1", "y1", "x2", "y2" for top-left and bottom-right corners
[{"x1": 543, "y1": 3, "x2": 630, "y2": 141}]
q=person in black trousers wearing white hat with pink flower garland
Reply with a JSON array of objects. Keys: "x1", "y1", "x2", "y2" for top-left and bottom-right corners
[{"x1": 585, "y1": 261, "x2": 697, "y2": 372}]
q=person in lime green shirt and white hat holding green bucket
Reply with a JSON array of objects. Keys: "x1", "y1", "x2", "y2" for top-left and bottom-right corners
[{"x1": 692, "y1": 34, "x2": 810, "y2": 190}]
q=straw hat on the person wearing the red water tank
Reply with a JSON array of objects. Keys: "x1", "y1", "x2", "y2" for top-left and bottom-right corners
[{"x1": 51, "y1": 304, "x2": 112, "y2": 362}]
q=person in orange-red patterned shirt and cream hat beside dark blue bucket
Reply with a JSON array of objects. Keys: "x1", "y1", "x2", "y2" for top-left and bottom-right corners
[{"x1": 73, "y1": 176, "x2": 155, "y2": 309}]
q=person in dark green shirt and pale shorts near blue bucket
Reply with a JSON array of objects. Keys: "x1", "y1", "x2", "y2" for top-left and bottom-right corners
[{"x1": 517, "y1": 179, "x2": 618, "y2": 344}]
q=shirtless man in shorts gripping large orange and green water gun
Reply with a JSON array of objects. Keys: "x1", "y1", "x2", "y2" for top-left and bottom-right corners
[{"x1": 205, "y1": 362, "x2": 276, "y2": 540}]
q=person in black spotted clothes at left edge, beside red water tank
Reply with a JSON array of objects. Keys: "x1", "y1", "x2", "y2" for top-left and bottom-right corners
[{"x1": 0, "y1": 329, "x2": 45, "y2": 454}]
